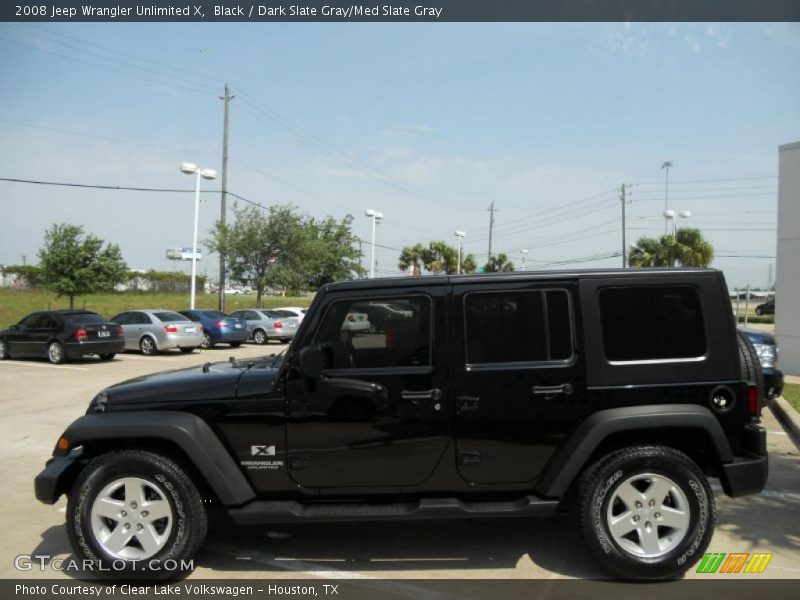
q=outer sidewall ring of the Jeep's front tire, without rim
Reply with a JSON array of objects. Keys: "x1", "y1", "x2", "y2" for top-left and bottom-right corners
[{"x1": 67, "y1": 456, "x2": 192, "y2": 577}]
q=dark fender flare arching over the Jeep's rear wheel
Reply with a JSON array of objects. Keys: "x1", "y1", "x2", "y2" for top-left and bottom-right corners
[{"x1": 535, "y1": 404, "x2": 734, "y2": 498}]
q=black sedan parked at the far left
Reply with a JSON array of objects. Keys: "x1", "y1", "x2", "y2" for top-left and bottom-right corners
[{"x1": 0, "y1": 310, "x2": 125, "y2": 364}]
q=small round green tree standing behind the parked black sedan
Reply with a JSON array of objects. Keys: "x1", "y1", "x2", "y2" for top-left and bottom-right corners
[{"x1": 39, "y1": 223, "x2": 127, "y2": 308}]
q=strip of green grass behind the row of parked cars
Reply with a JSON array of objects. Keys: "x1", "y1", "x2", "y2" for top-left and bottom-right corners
[{"x1": 0, "y1": 288, "x2": 312, "y2": 329}]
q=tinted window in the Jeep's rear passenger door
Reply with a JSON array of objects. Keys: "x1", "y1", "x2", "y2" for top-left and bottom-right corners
[{"x1": 464, "y1": 290, "x2": 573, "y2": 365}]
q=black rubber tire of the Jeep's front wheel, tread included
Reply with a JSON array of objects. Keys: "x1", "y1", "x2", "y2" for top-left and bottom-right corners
[{"x1": 67, "y1": 450, "x2": 208, "y2": 579}]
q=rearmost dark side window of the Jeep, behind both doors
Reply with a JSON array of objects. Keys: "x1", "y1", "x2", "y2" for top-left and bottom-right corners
[{"x1": 600, "y1": 286, "x2": 706, "y2": 362}]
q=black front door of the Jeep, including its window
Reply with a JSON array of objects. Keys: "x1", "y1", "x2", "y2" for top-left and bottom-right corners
[{"x1": 286, "y1": 286, "x2": 448, "y2": 488}]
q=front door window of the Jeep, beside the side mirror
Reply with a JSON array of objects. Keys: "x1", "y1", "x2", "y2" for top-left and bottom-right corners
[{"x1": 315, "y1": 297, "x2": 431, "y2": 369}]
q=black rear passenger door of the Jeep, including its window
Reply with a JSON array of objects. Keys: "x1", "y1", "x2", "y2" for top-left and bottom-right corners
[{"x1": 453, "y1": 281, "x2": 586, "y2": 484}]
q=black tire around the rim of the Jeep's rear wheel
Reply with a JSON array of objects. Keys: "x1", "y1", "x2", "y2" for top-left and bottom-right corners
[{"x1": 584, "y1": 454, "x2": 714, "y2": 579}]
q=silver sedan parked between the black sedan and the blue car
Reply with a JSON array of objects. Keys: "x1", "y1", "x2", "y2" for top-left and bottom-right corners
[{"x1": 111, "y1": 309, "x2": 203, "y2": 356}]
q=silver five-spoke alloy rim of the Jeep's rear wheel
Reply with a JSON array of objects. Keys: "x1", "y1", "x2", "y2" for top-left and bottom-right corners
[{"x1": 606, "y1": 473, "x2": 691, "y2": 558}]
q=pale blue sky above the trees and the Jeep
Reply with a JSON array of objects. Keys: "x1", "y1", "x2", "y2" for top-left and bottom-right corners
[{"x1": 0, "y1": 23, "x2": 800, "y2": 286}]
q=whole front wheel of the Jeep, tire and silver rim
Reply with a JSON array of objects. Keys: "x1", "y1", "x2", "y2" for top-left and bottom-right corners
[{"x1": 67, "y1": 450, "x2": 207, "y2": 579}]
